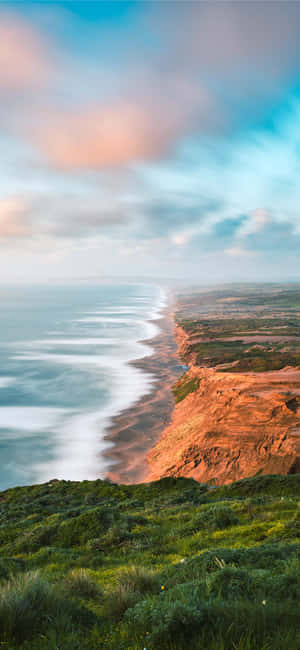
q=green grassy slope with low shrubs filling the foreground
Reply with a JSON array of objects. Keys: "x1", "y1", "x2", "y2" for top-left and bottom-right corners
[{"x1": 0, "y1": 475, "x2": 300, "y2": 650}]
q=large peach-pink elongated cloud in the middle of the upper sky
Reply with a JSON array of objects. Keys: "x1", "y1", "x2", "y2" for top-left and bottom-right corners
[{"x1": 32, "y1": 89, "x2": 212, "y2": 169}]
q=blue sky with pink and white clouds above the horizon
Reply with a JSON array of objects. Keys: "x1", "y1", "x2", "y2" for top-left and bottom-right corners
[{"x1": 0, "y1": 0, "x2": 300, "y2": 284}]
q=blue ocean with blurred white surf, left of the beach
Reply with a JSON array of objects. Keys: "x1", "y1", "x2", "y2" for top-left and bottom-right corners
[{"x1": 0, "y1": 284, "x2": 165, "y2": 489}]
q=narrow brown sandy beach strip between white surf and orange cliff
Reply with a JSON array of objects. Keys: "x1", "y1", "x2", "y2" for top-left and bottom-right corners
[{"x1": 104, "y1": 303, "x2": 184, "y2": 484}]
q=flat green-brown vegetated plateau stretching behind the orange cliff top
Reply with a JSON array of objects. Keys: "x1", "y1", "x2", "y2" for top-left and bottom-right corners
[{"x1": 176, "y1": 285, "x2": 300, "y2": 372}]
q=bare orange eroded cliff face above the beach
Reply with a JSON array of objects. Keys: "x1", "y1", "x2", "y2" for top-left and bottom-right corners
[{"x1": 147, "y1": 354, "x2": 300, "y2": 485}]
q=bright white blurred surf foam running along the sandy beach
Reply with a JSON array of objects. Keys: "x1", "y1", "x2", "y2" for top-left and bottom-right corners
[{"x1": 15, "y1": 282, "x2": 163, "y2": 481}]
